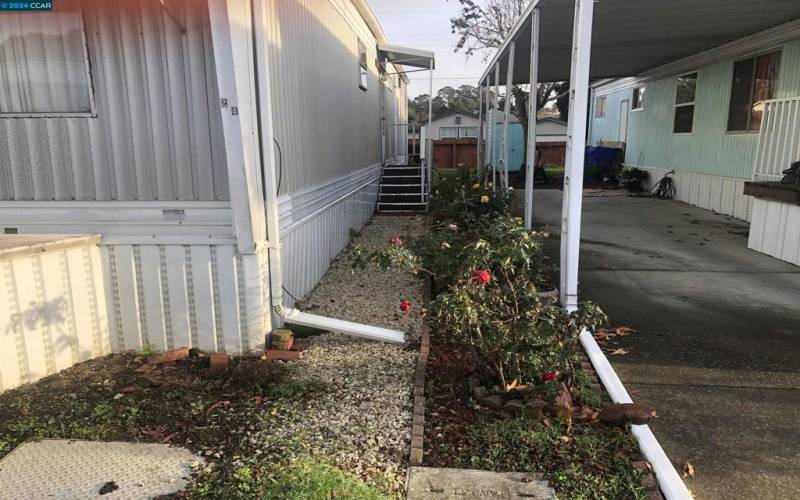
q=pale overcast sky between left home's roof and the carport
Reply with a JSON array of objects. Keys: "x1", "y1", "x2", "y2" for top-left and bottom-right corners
[{"x1": 368, "y1": 0, "x2": 486, "y2": 98}]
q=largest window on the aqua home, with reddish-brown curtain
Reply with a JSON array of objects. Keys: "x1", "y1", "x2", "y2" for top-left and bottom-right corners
[{"x1": 728, "y1": 52, "x2": 781, "y2": 132}]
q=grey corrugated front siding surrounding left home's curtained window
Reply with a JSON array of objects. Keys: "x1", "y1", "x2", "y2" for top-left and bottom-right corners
[{"x1": 0, "y1": 0, "x2": 228, "y2": 201}]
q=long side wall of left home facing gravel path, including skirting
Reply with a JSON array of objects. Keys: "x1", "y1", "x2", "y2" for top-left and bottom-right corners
[{"x1": 268, "y1": 0, "x2": 406, "y2": 304}]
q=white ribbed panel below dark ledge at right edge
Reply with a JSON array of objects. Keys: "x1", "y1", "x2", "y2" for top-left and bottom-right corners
[{"x1": 747, "y1": 198, "x2": 800, "y2": 266}]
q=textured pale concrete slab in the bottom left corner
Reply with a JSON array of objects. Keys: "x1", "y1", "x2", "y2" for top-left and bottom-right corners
[{"x1": 0, "y1": 439, "x2": 202, "y2": 500}]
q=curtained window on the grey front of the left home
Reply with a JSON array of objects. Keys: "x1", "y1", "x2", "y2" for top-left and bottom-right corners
[{"x1": 0, "y1": 12, "x2": 92, "y2": 115}]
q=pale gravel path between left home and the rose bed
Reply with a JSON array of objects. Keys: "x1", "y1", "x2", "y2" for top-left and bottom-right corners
[{"x1": 254, "y1": 216, "x2": 425, "y2": 496}]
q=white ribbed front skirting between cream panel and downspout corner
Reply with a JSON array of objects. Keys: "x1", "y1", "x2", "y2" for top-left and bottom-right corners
[{"x1": 103, "y1": 244, "x2": 269, "y2": 354}]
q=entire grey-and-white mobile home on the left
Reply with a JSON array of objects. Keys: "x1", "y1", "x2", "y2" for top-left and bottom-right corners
[{"x1": 0, "y1": 0, "x2": 432, "y2": 390}]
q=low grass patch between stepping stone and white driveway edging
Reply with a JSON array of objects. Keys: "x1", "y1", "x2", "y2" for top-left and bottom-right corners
[{"x1": 460, "y1": 416, "x2": 645, "y2": 500}]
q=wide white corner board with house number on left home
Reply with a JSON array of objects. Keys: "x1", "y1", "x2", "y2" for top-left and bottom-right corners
[{"x1": 208, "y1": 0, "x2": 266, "y2": 253}]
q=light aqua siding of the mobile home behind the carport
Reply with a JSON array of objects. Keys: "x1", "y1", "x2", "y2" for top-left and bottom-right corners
[{"x1": 590, "y1": 41, "x2": 800, "y2": 220}]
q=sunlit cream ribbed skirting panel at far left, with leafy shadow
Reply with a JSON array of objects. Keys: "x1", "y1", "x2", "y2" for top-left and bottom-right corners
[{"x1": 0, "y1": 237, "x2": 111, "y2": 392}]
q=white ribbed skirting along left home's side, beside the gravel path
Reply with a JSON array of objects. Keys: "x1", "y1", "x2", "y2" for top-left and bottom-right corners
[{"x1": 279, "y1": 165, "x2": 381, "y2": 305}]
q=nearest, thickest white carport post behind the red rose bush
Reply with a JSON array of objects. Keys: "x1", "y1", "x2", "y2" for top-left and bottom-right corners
[{"x1": 561, "y1": 0, "x2": 594, "y2": 312}]
